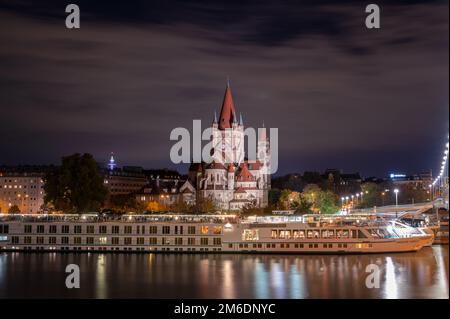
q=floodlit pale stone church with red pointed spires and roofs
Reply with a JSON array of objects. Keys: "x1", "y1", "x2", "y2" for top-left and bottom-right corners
[{"x1": 189, "y1": 85, "x2": 270, "y2": 210}]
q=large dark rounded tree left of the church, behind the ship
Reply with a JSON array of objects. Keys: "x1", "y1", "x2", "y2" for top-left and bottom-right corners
[{"x1": 44, "y1": 153, "x2": 108, "y2": 212}]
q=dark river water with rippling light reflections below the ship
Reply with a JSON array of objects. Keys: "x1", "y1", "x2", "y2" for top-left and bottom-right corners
[{"x1": 0, "y1": 246, "x2": 449, "y2": 299}]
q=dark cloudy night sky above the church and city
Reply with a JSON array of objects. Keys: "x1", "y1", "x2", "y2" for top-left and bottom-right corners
[{"x1": 0, "y1": 0, "x2": 449, "y2": 176}]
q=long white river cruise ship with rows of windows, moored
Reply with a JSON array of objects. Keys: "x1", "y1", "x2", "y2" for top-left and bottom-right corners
[{"x1": 0, "y1": 214, "x2": 433, "y2": 254}]
